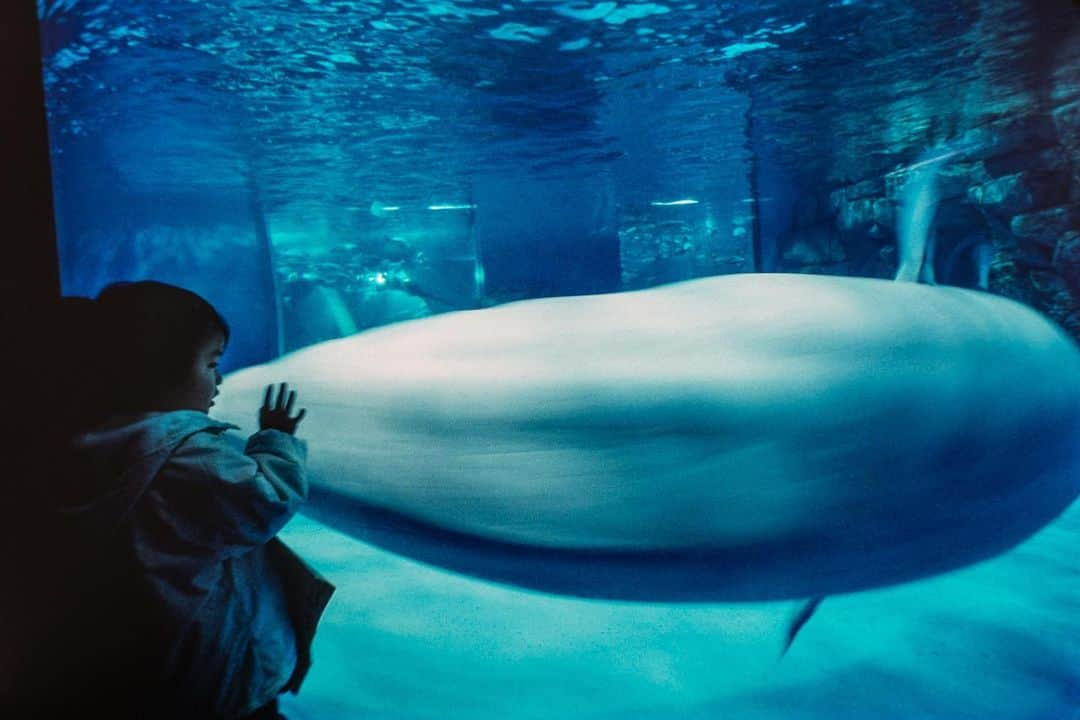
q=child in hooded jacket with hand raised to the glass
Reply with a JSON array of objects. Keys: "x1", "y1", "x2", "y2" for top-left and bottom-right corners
[{"x1": 24, "y1": 282, "x2": 333, "y2": 718}]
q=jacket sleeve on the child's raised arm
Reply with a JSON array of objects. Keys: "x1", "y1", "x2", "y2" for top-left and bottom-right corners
[{"x1": 139, "y1": 430, "x2": 308, "y2": 565}]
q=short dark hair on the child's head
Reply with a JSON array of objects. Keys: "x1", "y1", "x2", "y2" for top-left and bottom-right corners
[{"x1": 94, "y1": 281, "x2": 229, "y2": 412}]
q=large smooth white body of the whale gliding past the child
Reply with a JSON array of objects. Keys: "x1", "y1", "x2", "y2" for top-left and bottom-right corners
[{"x1": 216, "y1": 274, "x2": 1080, "y2": 601}]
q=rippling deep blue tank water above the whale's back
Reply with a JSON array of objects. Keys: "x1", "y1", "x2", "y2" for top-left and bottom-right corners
[{"x1": 39, "y1": 0, "x2": 1053, "y2": 367}]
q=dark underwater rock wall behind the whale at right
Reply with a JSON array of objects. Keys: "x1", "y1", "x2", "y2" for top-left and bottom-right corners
[{"x1": 781, "y1": 106, "x2": 1080, "y2": 339}]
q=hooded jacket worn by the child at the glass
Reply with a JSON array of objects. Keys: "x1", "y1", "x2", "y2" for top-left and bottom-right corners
[{"x1": 31, "y1": 410, "x2": 333, "y2": 718}]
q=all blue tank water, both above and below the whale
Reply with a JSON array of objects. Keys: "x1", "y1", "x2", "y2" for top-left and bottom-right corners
[{"x1": 39, "y1": 0, "x2": 1080, "y2": 720}]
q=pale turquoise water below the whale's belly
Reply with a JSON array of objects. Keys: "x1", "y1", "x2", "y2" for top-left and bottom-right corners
[{"x1": 284, "y1": 507, "x2": 1080, "y2": 720}]
